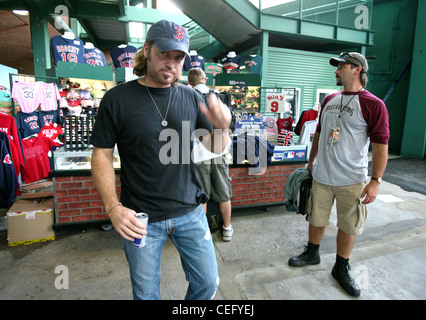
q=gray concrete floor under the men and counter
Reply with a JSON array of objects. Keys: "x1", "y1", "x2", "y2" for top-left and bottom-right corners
[{"x1": 0, "y1": 172, "x2": 426, "y2": 300}]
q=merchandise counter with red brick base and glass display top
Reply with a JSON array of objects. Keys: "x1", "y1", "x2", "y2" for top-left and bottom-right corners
[{"x1": 50, "y1": 148, "x2": 306, "y2": 227}]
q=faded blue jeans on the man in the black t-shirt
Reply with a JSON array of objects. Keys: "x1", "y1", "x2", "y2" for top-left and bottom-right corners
[{"x1": 124, "y1": 205, "x2": 219, "y2": 300}]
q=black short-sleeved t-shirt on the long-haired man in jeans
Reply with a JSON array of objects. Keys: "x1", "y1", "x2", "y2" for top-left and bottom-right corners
[{"x1": 90, "y1": 80, "x2": 212, "y2": 222}]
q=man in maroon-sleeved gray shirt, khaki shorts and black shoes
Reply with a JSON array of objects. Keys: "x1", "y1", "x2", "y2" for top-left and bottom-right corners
[{"x1": 289, "y1": 52, "x2": 389, "y2": 297}]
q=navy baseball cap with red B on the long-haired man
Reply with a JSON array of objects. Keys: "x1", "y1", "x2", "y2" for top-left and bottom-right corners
[{"x1": 146, "y1": 20, "x2": 189, "y2": 56}]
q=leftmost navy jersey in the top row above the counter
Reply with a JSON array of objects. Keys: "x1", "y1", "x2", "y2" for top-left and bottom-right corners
[{"x1": 50, "y1": 35, "x2": 84, "y2": 65}]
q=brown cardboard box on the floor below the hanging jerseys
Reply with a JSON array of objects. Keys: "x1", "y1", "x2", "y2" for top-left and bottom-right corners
[{"x1": 7, "y1": 197, "x2": 55, "y2": 246}]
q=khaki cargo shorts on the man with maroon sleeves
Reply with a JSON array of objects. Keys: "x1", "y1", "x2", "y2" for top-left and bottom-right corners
[{"x1": 307, "y1": 179, "x2": 367, "y2": 236}]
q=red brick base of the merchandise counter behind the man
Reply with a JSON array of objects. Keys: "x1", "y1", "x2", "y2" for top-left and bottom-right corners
[{"x1": 53, "y1": 163, "x2": 305, "y2": 224}]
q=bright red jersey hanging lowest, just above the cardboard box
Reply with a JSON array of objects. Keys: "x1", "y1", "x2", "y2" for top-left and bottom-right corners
[{"x1": 22, "y1": 135, "x2": 54, "y2": 183}]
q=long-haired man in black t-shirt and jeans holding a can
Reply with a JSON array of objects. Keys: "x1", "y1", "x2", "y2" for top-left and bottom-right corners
[{"x1": 91, "y1": 20, "x2": 231, "y2": 299}]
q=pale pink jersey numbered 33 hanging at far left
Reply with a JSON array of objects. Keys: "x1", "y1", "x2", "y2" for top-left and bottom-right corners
[{"x1": 12, "y1": 81, "x2": 42, "y2": 112}]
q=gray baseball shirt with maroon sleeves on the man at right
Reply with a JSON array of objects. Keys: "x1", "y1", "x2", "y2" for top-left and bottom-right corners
[{"x1": 312, "y1": 90, "x2": 390, "y2": 186}]
